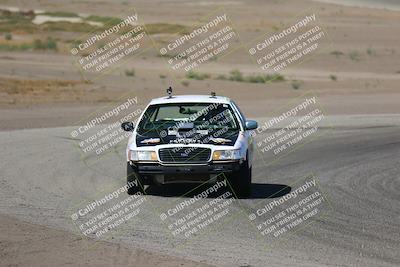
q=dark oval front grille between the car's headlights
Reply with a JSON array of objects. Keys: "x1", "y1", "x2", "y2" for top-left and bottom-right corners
[{"x1": 158, "y1": 146, "x2": 211, "y2": 163}]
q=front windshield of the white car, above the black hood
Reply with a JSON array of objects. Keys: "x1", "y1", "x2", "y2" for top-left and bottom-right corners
[{"x1": 138, "y1": 103, "x2": 239, "y2": 134}]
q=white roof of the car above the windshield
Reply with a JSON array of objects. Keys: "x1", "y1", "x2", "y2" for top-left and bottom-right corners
[{"x1": 150, "y1": 95, "x2": 231, "y2": 105}]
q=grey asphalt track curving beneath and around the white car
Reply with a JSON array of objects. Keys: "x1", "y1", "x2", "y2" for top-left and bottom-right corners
[{"x1": 0, "y1": 115, "x2": 400, "y2": 266}]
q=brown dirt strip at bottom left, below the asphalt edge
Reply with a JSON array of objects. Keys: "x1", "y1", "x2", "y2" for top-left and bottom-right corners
[{"x1": 0, "y1": 215, "x2": 210, "y2": 267}]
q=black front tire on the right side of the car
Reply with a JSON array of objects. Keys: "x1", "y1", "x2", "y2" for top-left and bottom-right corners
[{"x1": 231, "y1": 161, "x2": 252, "y2": 197}]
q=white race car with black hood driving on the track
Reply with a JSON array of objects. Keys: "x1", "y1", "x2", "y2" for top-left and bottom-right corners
[{"x1": 121, "y1": 89, "x2": 257, "y2": 197}]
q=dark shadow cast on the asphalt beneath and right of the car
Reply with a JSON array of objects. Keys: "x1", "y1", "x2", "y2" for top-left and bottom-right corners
[{"x1": 146, "y1": 183, "x2": 292, "y2": 199}]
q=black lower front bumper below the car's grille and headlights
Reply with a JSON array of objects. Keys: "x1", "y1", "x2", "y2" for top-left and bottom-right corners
[{"x1": 130, "y1": 161, "x2": 241, "y2": 184}]
